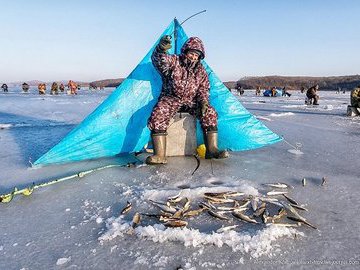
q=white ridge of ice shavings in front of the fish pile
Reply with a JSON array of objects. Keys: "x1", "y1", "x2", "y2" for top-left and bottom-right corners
[{"x1": 99, "y1": 217, "x2": 303, "y2": 258}]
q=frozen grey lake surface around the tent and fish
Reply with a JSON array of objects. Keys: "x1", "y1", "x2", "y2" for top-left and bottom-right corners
[{"x1": 0, "y1": 88, "x2": 360, "y2": 270}]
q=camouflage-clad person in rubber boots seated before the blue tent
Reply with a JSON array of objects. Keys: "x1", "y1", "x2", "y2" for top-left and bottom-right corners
[{"x1": 146, "y1": 36, "x2": 229, "y2": 164}]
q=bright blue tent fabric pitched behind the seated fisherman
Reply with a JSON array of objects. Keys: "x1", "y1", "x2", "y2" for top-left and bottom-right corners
[{"x1": 34, "y1": 20, "x2": 281, "y2": 166}]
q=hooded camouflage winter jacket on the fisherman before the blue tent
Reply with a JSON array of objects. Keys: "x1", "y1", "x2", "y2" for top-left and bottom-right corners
[{"x1": 151, "y1": 37, "x2": 210, "y2": 107}]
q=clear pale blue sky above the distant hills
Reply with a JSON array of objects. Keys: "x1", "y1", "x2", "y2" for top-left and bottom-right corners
[{"x1": 0, "y1": 0, "x2": 360, "y2": 83}]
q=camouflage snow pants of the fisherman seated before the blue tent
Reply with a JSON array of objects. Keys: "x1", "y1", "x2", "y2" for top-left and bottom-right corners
[{"x1": 148, "y1": 96, "x2": 217, "y2": 133}]
